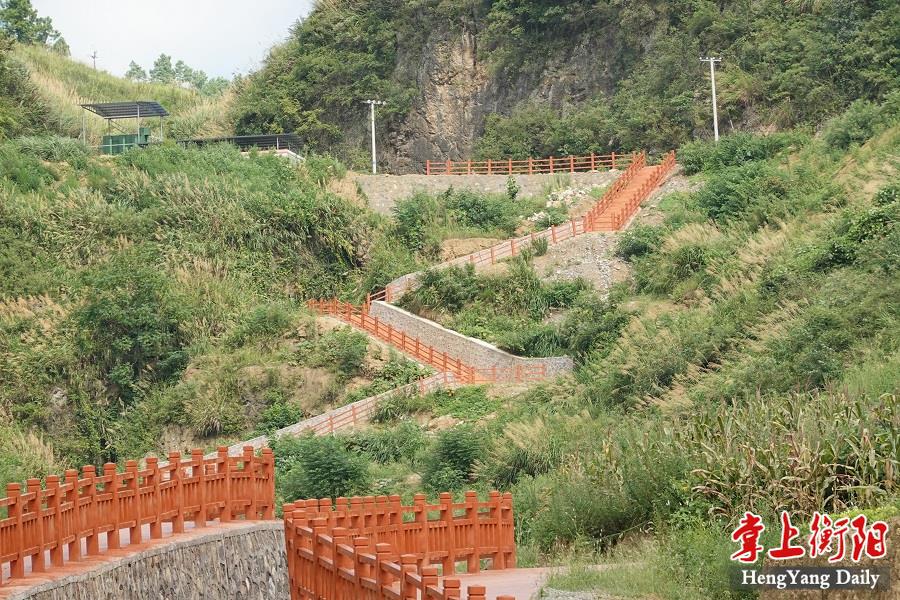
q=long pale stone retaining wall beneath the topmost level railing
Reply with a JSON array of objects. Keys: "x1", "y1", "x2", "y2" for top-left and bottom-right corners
[{"x1": 353, "y1": 171, "x2": 619, "y2": 214}]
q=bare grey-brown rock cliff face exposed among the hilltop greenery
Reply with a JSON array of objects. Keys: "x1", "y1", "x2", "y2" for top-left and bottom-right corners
[{"x1": 383, "y1": 25, "x2": 617, "y2": 173}]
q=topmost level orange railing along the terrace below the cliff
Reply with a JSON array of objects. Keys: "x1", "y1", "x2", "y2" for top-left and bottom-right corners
[{"x1": 425, "y1": 152, "x2": 633, "y2": 175}]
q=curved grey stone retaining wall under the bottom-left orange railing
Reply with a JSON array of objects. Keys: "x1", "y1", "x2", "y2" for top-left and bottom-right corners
[{"x1": 7, "y1": 521, "x2": 290, "y2": 600}]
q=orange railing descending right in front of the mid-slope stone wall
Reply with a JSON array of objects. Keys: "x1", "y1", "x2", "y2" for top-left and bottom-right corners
[{"x1": 307, "y1": 299, "x2": 547, "y2": 384}]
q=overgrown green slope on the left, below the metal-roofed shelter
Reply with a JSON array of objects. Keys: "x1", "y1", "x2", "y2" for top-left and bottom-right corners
[{"x1": 0, "y1": 137, "x2": 418, "y2": 476}]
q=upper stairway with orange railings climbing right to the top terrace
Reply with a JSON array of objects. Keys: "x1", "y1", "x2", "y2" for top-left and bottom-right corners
[{"x1": 367, "y1": 152, "x2": 675, "y2": 302}]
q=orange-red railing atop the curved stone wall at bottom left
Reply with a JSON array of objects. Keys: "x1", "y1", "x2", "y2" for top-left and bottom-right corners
[{"x1": 0, "y1": 447, "x2": 275, "y2": 585}]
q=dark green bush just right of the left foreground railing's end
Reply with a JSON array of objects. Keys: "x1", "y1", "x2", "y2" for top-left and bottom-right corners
[{"x1": 271, "y1": 434, "x2": 368, "y2": 502}]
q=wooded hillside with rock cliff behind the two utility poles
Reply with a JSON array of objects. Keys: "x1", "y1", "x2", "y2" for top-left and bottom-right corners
[{"x1": 234, "y1": 0, "x2": 900, "y2": 172}]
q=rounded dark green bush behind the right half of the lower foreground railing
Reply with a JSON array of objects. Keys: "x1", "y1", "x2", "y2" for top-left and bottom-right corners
[{"x1": 422, "y1": 425, "x2": 485, "y2": 492}]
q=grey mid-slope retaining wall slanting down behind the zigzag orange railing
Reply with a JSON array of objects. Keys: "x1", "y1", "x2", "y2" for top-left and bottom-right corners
[{"x1": 369, "y1": 302, "x2": 573, "y2": 377}]
